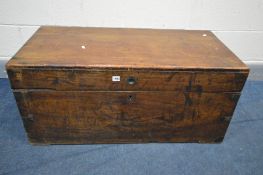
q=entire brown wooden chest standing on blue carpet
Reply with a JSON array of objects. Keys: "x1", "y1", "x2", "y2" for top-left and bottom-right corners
[{"x1": 6, "y1": 27, "x2": 249, "y2": 144}]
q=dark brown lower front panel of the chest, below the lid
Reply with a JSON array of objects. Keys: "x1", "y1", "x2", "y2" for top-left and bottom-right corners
[{"x1": 15, "y1": 90, "x2": 239, "y2": 144}]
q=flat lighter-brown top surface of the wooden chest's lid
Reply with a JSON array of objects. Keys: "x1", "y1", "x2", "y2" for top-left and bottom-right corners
[{"x1": 7, "y1": 27, "x2": 248, "y2": 70}]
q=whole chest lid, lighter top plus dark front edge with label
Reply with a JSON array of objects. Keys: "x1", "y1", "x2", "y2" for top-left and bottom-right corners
[{"x1": 6, "y1": 27, "x2": 248, "y2": 92}]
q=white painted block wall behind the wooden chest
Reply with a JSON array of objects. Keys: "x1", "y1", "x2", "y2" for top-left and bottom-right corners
[{"x1": 0, "y1": 0, "x2": 263, "y2": 76}]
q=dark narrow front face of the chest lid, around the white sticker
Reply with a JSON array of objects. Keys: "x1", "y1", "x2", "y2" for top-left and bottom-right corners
[{"x1": 8, "y1": 69, "x2": 248, "y2": 92}]
